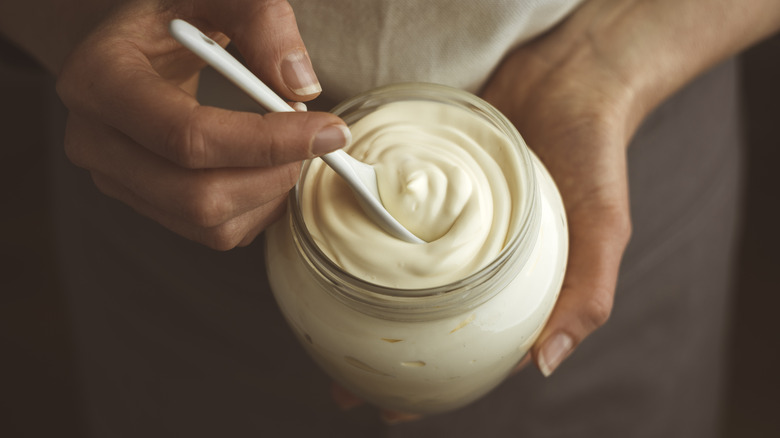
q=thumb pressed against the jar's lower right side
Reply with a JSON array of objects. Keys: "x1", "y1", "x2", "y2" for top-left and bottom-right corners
[{"x1": 532, "y1": 207, "x2": 631, "y2": 376}]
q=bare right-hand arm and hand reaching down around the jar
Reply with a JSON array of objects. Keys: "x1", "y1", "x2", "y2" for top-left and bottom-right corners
[{"x1": 483, "y1": 0, "x2": 780, "y2": 375}]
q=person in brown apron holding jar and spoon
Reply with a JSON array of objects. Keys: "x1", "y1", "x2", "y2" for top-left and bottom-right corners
[{"x1": 0, "y1": 0, "x2": 780, "y2": 437}]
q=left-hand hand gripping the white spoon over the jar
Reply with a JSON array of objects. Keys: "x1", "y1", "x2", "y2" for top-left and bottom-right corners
[{"x1": 57, "y1": 0, "x2": 349, "y2": 250}]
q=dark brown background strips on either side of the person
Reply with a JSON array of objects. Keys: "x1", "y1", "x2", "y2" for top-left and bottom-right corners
[{"x1": 0, "y1": 37, "x2": 780, "y2": 438}]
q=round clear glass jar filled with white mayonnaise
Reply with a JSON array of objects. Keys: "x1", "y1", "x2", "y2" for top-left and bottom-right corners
[{"x1": 266, "y1": 84, "x2": 568, "y2": 414}]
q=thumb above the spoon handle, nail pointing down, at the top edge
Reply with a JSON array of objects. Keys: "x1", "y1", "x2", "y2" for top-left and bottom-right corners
[{"x1": 195, "y1": 0, "x2": 322, "y2": 100}]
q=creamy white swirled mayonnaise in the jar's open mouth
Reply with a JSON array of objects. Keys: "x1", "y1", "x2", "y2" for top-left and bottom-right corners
[{"x1": 301, "y1": 101, "x2": 523, "y2": 289}]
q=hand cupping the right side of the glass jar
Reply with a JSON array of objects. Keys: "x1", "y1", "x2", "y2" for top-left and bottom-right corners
[{"x1": 483, "y1": 24, "x2": 640, "y2": 376}]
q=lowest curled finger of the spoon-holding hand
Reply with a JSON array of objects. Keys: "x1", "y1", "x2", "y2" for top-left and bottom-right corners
[{"x1": 91, "y1": 171, "x2": 287, "y2": 251}]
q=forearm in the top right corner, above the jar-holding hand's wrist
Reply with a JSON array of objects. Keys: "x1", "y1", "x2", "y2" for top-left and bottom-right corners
[{"x1": 594, "y1": 0, "x2": 780, "y2": 122}]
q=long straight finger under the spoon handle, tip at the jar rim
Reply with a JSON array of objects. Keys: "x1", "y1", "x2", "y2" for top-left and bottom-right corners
[{"x1": 62, "y1": 58, "x2": 350, "y2": 168}]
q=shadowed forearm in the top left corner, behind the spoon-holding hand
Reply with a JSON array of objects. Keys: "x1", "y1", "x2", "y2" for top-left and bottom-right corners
[{"x1": 0, "y1": 0, "x2": 122, "y2": 74}]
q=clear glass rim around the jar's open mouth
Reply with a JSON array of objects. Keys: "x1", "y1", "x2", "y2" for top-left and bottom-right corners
[{"x1": 288, "y1": 82, "x2": 541, "y2": 316}]
